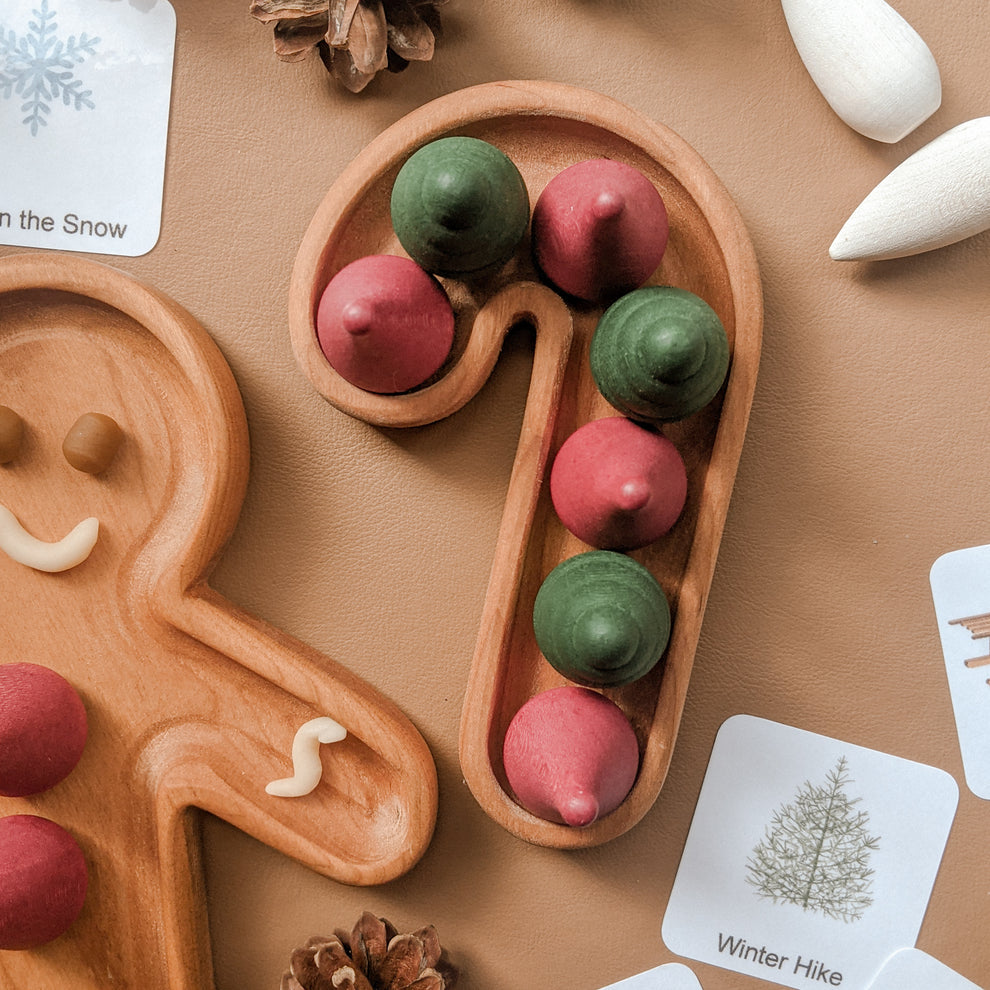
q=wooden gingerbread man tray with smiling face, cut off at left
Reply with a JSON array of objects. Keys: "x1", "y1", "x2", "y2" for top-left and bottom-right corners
[{"x1": 0, "y1": 254, "x2": 437, "y2": 990}]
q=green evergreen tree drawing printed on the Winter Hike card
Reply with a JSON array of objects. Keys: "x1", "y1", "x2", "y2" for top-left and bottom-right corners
[{"x1": 746, "y1": 756, "x2": 880, "y2": 922}]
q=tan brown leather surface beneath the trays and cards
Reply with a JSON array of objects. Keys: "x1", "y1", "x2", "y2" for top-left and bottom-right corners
[{"x1": 3, "y1": 0, "x2": 990, "y2": 990}]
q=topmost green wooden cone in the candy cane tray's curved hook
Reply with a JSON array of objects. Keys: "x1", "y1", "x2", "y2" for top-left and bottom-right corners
[{"x1": 391, "y1": 137, "x2": 529, "y2": 276}]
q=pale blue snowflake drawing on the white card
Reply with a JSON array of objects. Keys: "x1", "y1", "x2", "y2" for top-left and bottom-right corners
[{"x1": 0, "y1": 0, "x2": 100, "y2": 136}]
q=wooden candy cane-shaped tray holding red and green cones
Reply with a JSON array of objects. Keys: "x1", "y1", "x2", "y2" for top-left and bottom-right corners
[{"x1": 289, "y1": 82, "x2": 763, "y2": 848}]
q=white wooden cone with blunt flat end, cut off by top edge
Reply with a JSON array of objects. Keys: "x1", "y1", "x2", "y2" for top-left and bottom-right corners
[{"x1": 781, "y1": 0, "x2": 942, "y2": 144}]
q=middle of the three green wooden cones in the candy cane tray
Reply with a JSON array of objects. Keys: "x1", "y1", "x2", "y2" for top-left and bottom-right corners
[{"x1": 588, "y1": 285, "x2": 729, "y2": 423}]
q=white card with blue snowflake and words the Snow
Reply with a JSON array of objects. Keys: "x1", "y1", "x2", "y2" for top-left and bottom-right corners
[{"x1": 0, "y1": 0, "x2": 175, "y2": 257}]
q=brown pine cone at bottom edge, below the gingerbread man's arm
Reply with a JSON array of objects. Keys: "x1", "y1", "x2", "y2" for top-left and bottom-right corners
[{"x1": 281, "y1": 911, "x2": 457, "y2": 990}]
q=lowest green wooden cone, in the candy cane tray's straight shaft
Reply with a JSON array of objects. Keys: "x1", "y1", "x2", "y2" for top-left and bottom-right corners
[{"x1": 533, "y1": 550, "x2": 670, "y2": 687}]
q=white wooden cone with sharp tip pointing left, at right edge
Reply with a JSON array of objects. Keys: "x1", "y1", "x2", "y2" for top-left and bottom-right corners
[{"x1": 829, "y1": 117, "x2": 990, "y2": 261}]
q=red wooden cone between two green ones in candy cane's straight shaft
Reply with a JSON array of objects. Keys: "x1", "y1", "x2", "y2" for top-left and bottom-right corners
[{"x1": 550, "y1": 416, "x2": 687, "y2": 550}]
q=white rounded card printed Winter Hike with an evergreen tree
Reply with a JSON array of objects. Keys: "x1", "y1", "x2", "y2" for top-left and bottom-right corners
[{"x1": 662, "y1": 715, "x2": 959, "y2": 990}]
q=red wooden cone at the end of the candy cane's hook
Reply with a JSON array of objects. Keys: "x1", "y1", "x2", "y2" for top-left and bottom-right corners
[{"x1": 316, "y1": 254, "x2": 454, "y2": 394}]
